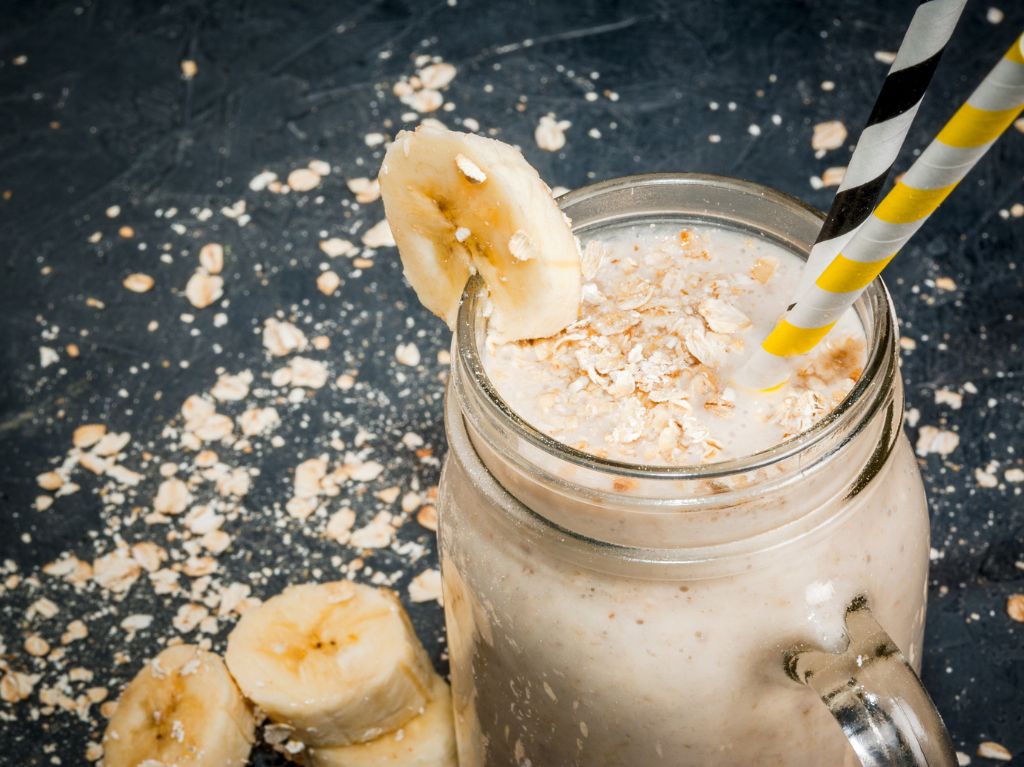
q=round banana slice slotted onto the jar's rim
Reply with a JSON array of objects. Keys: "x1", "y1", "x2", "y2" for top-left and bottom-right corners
[{"x1": 380, "y1": 125, "x2": 581, "y2": 340}]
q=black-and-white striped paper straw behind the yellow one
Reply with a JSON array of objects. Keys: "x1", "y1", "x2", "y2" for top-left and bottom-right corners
[{"x1": 797, "y1": 0, "x2": 967, "y2": 295}]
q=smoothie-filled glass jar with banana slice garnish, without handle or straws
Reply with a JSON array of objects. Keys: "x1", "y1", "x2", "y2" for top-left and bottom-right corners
[{"x1": 380, "y1": 128, "x2": 929, "y2": 767}]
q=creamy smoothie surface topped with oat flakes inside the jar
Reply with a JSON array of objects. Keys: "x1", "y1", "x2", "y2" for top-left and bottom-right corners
[{"x1": 483, "y1": 224, "x2": 865, "y2": 466}]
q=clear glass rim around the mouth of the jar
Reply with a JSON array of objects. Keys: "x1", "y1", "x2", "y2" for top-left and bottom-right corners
[{"x1": 455, "y1": 173, "x2": 896, "y2": 480}]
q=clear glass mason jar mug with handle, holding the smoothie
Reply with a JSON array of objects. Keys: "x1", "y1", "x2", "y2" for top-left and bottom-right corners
[{"x1": 438, "y1": 174, "x2": 956, "y2": 767}]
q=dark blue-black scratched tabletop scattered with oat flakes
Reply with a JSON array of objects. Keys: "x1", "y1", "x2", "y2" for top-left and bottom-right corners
[{"x1": 0, "y1": 0, "x2": 1024, "y2": 767}]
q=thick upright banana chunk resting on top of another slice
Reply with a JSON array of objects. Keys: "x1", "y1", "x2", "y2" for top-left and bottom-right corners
[{"x1": 225, "y1": 581, "x2": 434, "y2": 745}]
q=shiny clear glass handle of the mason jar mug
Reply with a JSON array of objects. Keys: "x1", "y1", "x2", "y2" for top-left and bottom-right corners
[{"x1": 785, "y1": 596, "x2": 957, "y2": 767}]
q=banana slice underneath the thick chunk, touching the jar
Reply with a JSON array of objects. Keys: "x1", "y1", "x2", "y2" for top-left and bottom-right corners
[{"x1": 309, "y1": 676, "x2": 458, "y2": 767}]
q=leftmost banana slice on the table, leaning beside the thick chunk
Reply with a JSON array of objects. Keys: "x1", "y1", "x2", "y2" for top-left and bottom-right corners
[{"x1": 103, "y1": 644, "x2": 255, "y2": 767}]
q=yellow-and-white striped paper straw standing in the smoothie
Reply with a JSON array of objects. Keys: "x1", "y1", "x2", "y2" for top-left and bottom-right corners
[{"x1": 736, "y1": 30, "x2": 1024, "y2": 391}]
